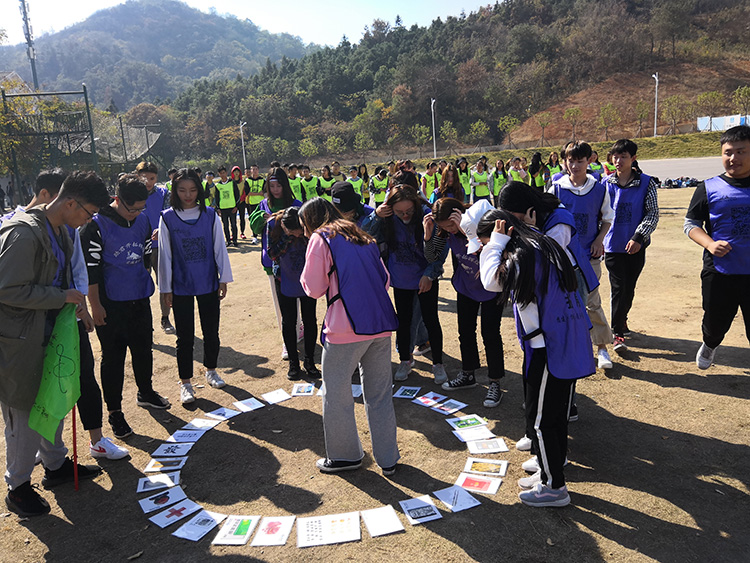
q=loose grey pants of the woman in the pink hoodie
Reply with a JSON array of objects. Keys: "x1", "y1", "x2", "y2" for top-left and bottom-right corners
[{"x1": 322, "y1": 337, "x2": 400, "y2": 467}]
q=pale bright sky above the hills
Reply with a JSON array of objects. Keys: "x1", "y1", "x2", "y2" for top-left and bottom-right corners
[{"x1": 0, "y1": 0, "x2": 494, "y2": 45}]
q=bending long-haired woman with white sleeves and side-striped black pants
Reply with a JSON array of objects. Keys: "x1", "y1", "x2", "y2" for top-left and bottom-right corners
[{"x1": 477, "y1": 210, "x2": 595, "y2": 507}]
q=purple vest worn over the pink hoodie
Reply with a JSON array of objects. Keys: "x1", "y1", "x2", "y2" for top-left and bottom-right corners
[{"x1": 318, "y1": 231, "x2": 398, "y2": 335}]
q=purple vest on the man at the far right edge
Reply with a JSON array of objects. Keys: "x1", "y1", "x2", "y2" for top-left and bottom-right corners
[{"x1": 705, "y1": 176, "x2": 750, "y2": 275}]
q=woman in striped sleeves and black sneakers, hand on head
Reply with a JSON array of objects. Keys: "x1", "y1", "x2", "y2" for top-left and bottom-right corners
[{"x1": 425, "y1": 198, "x2": 505, "y2": 408}]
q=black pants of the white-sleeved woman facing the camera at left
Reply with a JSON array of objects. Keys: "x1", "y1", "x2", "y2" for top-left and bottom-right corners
[{"x1": 172, "y1": 291, "x2": 220, "y2": 379}]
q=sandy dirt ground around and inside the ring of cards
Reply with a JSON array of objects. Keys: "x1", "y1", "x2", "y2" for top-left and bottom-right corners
[{"x1": 0, "y1": 189, "x2": 750, "y2": 563}]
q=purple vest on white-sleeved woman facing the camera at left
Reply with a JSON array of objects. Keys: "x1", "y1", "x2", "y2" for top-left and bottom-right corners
[{"x1": 161, "y1": 207, "x2": 219, "y2": 295}]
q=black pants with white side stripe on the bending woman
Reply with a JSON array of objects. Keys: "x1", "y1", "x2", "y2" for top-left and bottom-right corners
[{"x1": 524, "y1": 348, "x2": 573, "y2": 489}]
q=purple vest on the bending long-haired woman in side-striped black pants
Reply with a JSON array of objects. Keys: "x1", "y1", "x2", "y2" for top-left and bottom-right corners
[{"x1": 513, "y1": 252, "x2": 596, "y2": 379}]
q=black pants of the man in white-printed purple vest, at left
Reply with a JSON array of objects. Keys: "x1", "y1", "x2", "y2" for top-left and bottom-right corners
[{"x1": 96, "y1": 299, "x2": 154, "y2": 412}]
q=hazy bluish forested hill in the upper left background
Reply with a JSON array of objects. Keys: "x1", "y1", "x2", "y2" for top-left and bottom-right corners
[{"x1": 0, "y1": 0, "x2": 315, "y2": 111}]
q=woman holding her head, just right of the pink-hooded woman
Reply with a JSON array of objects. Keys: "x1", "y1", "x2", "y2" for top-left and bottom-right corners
[{"x1": 369, "y1": 185, "x2": 448, "y2": 385}]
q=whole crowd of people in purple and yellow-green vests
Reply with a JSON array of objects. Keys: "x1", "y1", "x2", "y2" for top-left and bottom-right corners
[{"x1": 0, "y1": 126, "x2": 750, "y2": 516}]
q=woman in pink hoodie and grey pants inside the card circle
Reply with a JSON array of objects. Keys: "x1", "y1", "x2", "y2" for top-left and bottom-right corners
[{"x1": 299, "y1": 198, "x2": 400, "y2": 476}]
